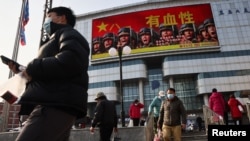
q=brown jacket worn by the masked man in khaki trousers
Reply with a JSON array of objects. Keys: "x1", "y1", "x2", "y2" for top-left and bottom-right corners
[{"x1": 158, "y1": 96, "x2": 187, "y2": 127}]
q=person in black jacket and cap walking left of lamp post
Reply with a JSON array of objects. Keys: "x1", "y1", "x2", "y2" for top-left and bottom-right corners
[{"x1": 90, "y1": 92, "x2": 118, "y2": 141}]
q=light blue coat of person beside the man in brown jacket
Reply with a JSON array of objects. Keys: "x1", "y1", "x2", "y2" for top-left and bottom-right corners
[{"x1": 148, "y1": 96, "x2": 162, "y2": 117}]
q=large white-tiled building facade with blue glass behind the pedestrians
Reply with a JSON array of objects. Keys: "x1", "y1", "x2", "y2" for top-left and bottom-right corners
[{"x1": 76, "y1": 0, "x2": 250, "y2": 117}]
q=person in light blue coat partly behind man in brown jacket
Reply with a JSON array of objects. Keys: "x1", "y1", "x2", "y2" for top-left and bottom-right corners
[{"x1": 148, "y1": 91, "x2": 165, "y2": 133}]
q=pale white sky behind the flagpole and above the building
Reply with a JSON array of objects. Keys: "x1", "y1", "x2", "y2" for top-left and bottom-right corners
[{"x1": 0, "y1": 0, "x2": 145, "y2": 84}]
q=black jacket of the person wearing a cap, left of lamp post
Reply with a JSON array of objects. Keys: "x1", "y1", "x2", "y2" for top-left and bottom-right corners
[{"x1": 92, "y1": 99, "x2": 117, "y2": 127}]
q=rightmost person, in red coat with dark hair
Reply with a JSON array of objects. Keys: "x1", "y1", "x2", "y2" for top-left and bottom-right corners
[{"x1": 228, "y1": 94, "x2": 243, "y2": 125}]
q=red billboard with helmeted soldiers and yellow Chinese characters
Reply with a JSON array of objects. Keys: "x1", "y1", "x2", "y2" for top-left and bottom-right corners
[{"x1": 91, "y1": 4, "x2": 219, "y2": 60}]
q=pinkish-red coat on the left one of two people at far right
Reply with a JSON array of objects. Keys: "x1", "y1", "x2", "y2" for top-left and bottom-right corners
[{"x1": 209, "y1": 92, "x2": 226, "y2": 117}]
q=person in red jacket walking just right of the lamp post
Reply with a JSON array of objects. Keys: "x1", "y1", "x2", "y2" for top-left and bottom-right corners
[{"x1": 129, "y1": 99, "x2": 144, "y2": 126}]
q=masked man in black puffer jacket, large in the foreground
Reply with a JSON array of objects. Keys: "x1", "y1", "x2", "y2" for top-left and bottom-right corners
[{"x1": 8, "y1": 7, "x2": 90, "y2": 141}]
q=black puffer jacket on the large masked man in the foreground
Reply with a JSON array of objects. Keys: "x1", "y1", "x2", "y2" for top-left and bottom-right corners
[{"x1": 19, "y1": 25, "x2": 90, "y2": 117}]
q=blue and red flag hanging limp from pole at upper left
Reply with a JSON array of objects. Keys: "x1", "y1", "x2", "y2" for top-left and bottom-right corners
[{"x1": 20, "y1": 0, "x2": 29, "y2": 45}]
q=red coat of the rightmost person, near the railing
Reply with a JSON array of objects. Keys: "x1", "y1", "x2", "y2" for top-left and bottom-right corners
[{"x1": 228, "y1": 98, "x2": 243, "y2": 119}]
